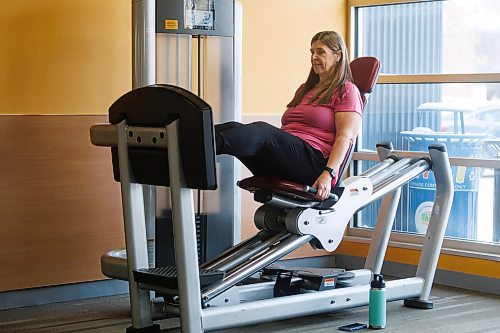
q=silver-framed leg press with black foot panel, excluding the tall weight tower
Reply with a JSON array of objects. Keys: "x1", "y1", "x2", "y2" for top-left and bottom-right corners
[{"x1": 90, "y1": 85, "x2": 453, "y2": 332}]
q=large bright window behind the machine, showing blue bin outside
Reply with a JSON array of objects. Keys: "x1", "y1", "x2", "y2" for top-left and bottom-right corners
[{"x1": 349, "y1": 0, "x2": 500, "y2": 254}]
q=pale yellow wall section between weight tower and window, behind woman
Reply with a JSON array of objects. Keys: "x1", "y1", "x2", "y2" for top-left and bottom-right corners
[{"x1": 241, "y1": 0, "x2": 347, "y2": 114}]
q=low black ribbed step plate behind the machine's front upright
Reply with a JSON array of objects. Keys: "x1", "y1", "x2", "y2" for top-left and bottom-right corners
[{"x1": 134, "y1": 266, "x2": 225, "y2": 289}]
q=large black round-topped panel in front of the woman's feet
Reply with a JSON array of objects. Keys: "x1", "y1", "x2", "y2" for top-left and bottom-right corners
[{"x1": 109, "y1": 85, "x2": 217, "y2": 190}]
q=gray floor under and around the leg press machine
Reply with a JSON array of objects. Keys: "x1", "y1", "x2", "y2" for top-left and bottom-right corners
[{"x1": 0, "y1": 286, "x2": 500, "y2": 333}]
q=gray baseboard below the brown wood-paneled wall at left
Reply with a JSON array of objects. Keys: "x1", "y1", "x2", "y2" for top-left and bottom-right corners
[{"x1": 0, "y1": 280, "x2": 128, "y2": 310}]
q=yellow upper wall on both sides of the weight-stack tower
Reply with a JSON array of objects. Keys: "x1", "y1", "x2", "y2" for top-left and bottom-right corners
[{"x1": 0, "y1": 0, "x2": 346, "y2": 114}]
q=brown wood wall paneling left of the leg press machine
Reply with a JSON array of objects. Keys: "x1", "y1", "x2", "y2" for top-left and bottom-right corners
[{"x1": 0, "y1": 115, "x2": 124, "y2": 291}]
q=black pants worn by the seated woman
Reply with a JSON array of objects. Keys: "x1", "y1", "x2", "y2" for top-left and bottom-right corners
[{"x1": 215, "y1": 122, "x2": 327, "y2": 185}]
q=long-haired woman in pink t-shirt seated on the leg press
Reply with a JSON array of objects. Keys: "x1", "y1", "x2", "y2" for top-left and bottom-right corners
[{"x1": 215, "y1": 31, "x2": 363, "y2": 200}]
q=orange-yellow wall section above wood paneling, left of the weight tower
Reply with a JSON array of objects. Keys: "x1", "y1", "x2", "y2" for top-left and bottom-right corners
[{"x1": 0, "y1": 0, "x2": 131, "y2": 114}]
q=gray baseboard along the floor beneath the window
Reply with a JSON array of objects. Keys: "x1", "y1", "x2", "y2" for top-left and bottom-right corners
[{"x1": 335, "y1": 254, "x2": 500, "y2": 295}]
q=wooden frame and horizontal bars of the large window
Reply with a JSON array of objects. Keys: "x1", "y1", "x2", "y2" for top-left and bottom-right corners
[{"x1": 344, "y1": 0, "x2": 500, "y2": 261}]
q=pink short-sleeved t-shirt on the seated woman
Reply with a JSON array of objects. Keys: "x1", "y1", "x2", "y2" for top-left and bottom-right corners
[{"x1": 281, "y1": 81, "x2": 363, "y2": 158}]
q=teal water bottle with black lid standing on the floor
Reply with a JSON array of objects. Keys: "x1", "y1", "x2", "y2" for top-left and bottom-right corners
[{"x1": 368, "y1": 274, "x2": 387, "y2": 329}]
